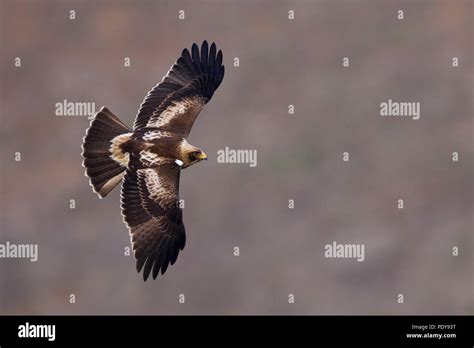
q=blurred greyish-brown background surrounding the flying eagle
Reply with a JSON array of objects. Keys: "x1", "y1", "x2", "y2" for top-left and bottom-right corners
[{"x1": 0, "y1": 0, "x2": 474, "y2": 314}]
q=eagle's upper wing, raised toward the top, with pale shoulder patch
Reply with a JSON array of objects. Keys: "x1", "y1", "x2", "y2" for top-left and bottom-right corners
[{"x1": 134, "y1": 41, "x2": 224, "y2": 137}]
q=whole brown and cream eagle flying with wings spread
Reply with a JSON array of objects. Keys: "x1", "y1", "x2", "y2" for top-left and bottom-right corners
[{"x1": 82, "y1": 41, "x2": 224, "y2": 281}]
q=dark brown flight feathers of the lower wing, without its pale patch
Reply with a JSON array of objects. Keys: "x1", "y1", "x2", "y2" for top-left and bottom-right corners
[{"x1": 121, "y1": 167, "x2": 186, "y2": 281}]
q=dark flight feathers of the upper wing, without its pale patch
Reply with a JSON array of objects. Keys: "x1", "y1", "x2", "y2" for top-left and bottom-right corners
[{"x1": 134, "y1": 41, "x2": 225, "y2": 133}]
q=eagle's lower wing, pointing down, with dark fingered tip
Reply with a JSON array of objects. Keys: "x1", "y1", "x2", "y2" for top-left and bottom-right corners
[{"x1": 121, "y1": 164, "x2": 186, "y2": 280}]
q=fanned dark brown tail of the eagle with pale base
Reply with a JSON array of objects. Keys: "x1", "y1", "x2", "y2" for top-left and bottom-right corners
[{"x1": 82, "y1": 107, "x2": 131, "y2": 198}]
